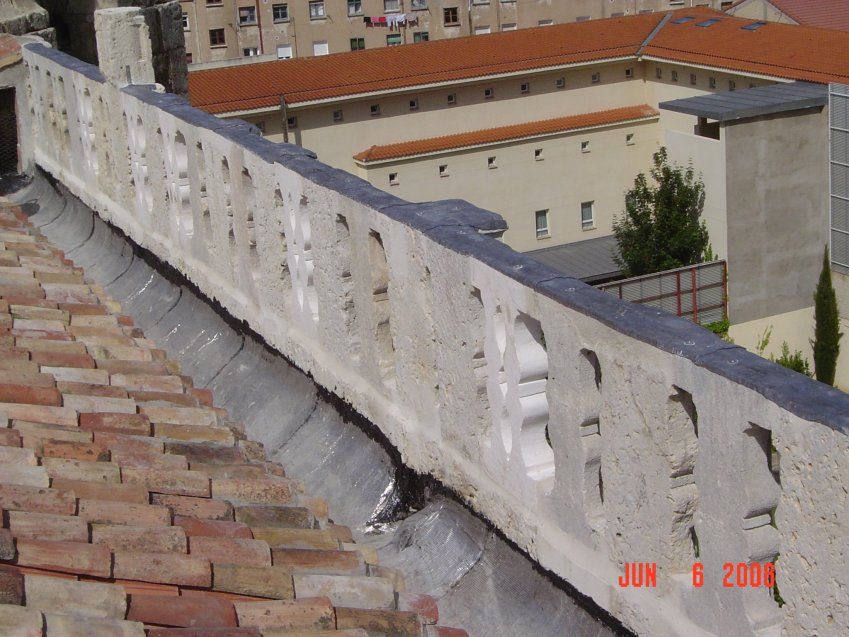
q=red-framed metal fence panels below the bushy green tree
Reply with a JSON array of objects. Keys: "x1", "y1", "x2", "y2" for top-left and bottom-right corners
[{"x1": 596, "y1": 261, "x2": 728, "y2": 324}]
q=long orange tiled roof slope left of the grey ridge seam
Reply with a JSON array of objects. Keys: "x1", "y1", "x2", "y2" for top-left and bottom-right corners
[{"x1": 189, "y1": 14, "x2": 662, "y2": 113}]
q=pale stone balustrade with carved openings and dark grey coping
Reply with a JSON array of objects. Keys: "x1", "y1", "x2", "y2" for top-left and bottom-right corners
[{"x1": 16, "y1": 44, "x2": 849, "y2": 636}]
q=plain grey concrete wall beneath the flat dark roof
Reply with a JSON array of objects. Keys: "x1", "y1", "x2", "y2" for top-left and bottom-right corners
[{"x1": 721, "y1": 109, "x2": 829, "y2": 323}]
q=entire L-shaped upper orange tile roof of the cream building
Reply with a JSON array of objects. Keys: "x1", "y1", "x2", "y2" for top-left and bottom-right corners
[{"x1": 189, "y1": 7, "x2": 849, "y2": 114}]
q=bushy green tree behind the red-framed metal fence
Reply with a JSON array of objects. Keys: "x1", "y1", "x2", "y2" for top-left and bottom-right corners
[{"x1": 613, "y1": 148, "x2": 710, "y2": 276}]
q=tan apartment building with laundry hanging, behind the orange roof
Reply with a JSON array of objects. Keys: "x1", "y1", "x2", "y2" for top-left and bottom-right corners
[{"x1": 181, "y1": 0, "x2": 731, "y2": 63}]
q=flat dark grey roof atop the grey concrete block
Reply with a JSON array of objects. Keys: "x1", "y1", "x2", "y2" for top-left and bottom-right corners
[{"x1": 660, "y1": 82, "x2": 828, "y2": 122}]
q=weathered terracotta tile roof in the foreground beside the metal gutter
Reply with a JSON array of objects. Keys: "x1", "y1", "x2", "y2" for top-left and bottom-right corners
[{"x1": 0, "y1": 199, "x2": 466, "y2": 637}]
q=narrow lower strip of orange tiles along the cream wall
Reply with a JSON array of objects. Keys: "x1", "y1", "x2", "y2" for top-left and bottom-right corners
[{"x1": 354, "y1": 104, "x2": 658, "y2": 163}]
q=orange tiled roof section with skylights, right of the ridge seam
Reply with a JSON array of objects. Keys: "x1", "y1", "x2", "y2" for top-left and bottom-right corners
[{"x1": 643, "y1": 8, "x2": 849, "y2": 84}]
